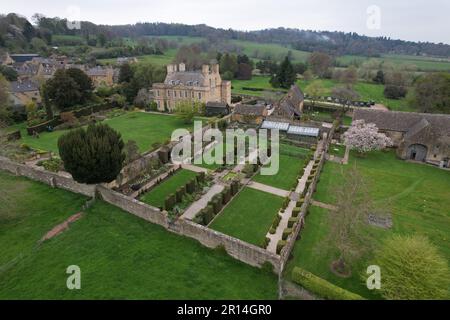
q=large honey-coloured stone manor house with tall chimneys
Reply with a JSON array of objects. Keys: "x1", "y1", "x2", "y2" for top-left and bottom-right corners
[{"x1": 152, "y1": 63, "x2": 231, "y2": 111}]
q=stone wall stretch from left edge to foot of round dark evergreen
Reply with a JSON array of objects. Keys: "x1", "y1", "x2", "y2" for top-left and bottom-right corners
[{"x1": 0, "y1": 157, "x2": 96, "y2": 197}]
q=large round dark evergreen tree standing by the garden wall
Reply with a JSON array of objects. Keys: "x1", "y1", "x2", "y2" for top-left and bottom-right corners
[{"x1": 58, "y1": 124, "x2": 125, "y2": 184}]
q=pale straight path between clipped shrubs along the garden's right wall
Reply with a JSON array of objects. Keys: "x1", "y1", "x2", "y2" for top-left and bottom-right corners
[{"x1": 267, "y1": 160, "x2": 314, "y2": 253}]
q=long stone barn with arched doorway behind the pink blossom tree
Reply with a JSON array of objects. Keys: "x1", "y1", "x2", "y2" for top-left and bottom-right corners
[{"x1": 353, "y1": 109, "x2": 450, "y2": 167}]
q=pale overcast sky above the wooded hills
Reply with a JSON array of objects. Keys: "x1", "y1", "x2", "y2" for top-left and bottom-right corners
[{"x1": 0, "y1": 0, "x2": 450, "y2": 44}]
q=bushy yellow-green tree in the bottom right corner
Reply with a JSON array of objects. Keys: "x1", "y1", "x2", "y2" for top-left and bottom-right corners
[{"x1": 373, "y1": 235, "x2": 450, "y2": 300}]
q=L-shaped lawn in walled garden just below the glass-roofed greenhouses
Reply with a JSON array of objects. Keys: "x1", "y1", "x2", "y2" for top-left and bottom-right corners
[{"x1": 253, "y1": 144, "x2": 309, "y2": 191}]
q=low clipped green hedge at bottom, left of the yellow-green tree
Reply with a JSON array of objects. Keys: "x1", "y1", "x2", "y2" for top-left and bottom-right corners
[{"x1": 292, "y1": 267, "x2": 364, "y2": 300}]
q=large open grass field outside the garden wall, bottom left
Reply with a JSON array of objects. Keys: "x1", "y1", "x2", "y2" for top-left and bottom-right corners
[{"x1": 0, "y1": 173, "x2": 277, "y2": 299}]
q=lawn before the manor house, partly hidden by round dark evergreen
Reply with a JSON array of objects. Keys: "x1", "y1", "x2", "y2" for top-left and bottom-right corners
[{"x1": 8, "y1": 112, "x2": 199, "y2": 153}]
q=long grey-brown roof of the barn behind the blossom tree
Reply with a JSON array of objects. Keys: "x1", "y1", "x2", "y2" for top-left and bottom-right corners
[{"x1": 353, "y1": 109, "x2": 450, "y2": 135}]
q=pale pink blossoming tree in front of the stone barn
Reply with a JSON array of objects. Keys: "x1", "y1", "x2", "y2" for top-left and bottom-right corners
[{"x1": 343, "y1": 120, "x2": 393, "y2": 154}]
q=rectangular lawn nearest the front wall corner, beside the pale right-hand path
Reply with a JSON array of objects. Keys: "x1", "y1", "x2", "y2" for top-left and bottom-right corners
[{"x1": 209, "y1": 187, "x2": 284, "y2": 246}]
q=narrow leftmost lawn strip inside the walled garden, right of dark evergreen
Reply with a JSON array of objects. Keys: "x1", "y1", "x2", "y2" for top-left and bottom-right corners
[{"x1": 140, "y1": 169, "x2": 197, "y2": 208}]
